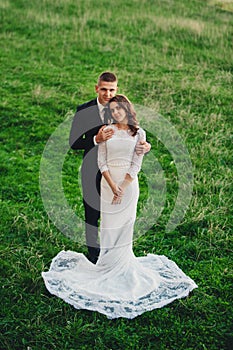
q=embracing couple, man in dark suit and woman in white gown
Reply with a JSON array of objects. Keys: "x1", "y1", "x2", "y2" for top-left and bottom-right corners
[{"x1": 42, "y1": 72, "x2": 197, "y2": 318}]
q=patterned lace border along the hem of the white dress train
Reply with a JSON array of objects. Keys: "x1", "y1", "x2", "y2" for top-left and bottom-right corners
[{"x1": 45, "y1": 254, "x2": 197, "y2": 319}]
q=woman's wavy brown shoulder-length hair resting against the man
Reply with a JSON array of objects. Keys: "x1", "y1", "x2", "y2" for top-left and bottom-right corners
[{"x1": 108, "y1": 94, "x2": 139, "y2": 136}]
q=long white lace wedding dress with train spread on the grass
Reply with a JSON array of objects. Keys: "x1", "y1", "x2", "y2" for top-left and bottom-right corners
[{"x1": 42, "y1": 126, "x2": 197, "y2": 319}]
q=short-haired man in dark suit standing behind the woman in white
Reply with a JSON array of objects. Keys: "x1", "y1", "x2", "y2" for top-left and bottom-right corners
[{"x1": 69, "y1": 72, "x2": 151, "y2": 263}]
